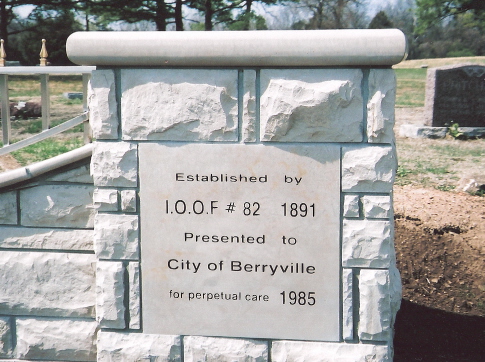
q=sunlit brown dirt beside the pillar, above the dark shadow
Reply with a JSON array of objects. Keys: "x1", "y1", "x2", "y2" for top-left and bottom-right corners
[{"x1": 394, "y1": 187, "x2": 485, "y2": 316}]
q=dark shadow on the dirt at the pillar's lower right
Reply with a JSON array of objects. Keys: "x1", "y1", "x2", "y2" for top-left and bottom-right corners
[{"x1": 394, "y1": 299, "x2": 485, "y2": 362}]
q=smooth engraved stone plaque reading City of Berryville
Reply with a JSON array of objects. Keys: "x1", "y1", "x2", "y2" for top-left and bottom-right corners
[{"x1": 139, "y1": 143, "x2": 340, "y2": 341}]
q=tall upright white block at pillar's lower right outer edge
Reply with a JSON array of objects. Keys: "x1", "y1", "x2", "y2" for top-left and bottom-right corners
[{"x1": 359, "y1": 269, "x2": 394, "y2": 342}]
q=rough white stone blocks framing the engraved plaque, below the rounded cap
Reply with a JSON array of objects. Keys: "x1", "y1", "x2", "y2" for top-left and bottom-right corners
[{"x1": 89, "y1": 68, "x2": 401, "y2": 362}]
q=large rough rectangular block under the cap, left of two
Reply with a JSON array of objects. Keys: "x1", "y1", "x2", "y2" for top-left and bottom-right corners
[{"x1": 121, "y1": 69, "x2": 238, "y2": 141}]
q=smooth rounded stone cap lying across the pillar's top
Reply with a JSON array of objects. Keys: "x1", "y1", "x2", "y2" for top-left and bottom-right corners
[{"x1": 66, "y1": 29, "x2": 406, "y2": 67}]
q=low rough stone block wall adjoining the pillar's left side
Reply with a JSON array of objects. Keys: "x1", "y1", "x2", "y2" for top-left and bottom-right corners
[{"x1": 0, "y1": 160, "x2": 98, "y2": 361}]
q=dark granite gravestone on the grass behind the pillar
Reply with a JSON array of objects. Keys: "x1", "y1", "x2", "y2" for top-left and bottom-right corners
[{"x1": 425, "y1": 65, "x2": 485, "y2": 127}]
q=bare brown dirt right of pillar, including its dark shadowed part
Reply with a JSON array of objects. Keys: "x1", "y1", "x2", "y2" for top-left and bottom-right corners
[{"x1": 394, "y1": 186, "x2": 485, "y2": 361}]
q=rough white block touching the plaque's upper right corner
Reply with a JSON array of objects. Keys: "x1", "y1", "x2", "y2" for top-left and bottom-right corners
[{"x1": 342, "y1": 146, "x2": 397, "y2": 192}]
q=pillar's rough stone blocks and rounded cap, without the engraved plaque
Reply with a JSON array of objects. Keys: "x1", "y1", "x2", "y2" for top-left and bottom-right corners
[{"x1": 68, "y1": 30, "x2": 405, "y2": 362}]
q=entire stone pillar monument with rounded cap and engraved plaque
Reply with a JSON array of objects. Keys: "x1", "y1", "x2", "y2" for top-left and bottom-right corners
[{"x1": 63, "y1": 29, "x2": 406, "y2": 362}]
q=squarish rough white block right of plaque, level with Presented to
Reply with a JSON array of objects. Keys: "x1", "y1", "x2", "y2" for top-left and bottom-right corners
[{"x1": 342, "y1": 220, "x2": 393, "y2": 268}]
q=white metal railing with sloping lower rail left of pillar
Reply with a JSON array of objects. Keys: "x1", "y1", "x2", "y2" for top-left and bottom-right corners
[{"x1": 0, "y1": 66, "x2": 96, "y2": 156}]
